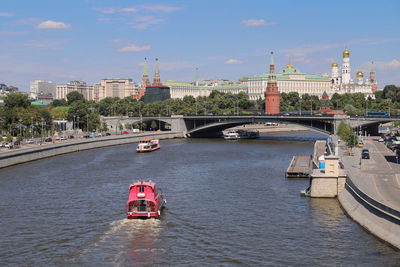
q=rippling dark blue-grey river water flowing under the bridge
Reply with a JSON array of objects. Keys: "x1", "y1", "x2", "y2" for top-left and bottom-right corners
[{"x1": 0, "y1": 132, "x2": 400, "y2": 266}]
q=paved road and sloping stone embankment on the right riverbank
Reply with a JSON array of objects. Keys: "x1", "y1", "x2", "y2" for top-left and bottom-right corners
[{"x1": 338, "y1": 138, "x2": 400, "y2": 249}]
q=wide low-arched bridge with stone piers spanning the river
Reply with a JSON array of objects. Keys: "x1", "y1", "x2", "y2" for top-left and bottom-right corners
[{"x1": 104, "y1": 115, "x2": 400, "y2": 137}]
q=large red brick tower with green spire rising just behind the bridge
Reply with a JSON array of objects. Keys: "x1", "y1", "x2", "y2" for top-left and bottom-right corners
[{"x1": 265, "y1": 52, "x2": 281, "y2": 115}]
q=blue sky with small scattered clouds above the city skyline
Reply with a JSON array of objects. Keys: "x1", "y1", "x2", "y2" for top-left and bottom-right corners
[{"x1": 0, "y1": 0, "x2": 400, "y2": 91}]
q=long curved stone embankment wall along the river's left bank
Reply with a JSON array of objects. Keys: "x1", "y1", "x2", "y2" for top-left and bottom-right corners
[{"x1": 0, "y1": 132, "x2": 183, "y2": 168}]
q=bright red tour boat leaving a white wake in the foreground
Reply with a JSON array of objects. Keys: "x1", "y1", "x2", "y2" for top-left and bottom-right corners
[{"x1": 126, "y1": 180, "x2": 167, "y2": 219}]
